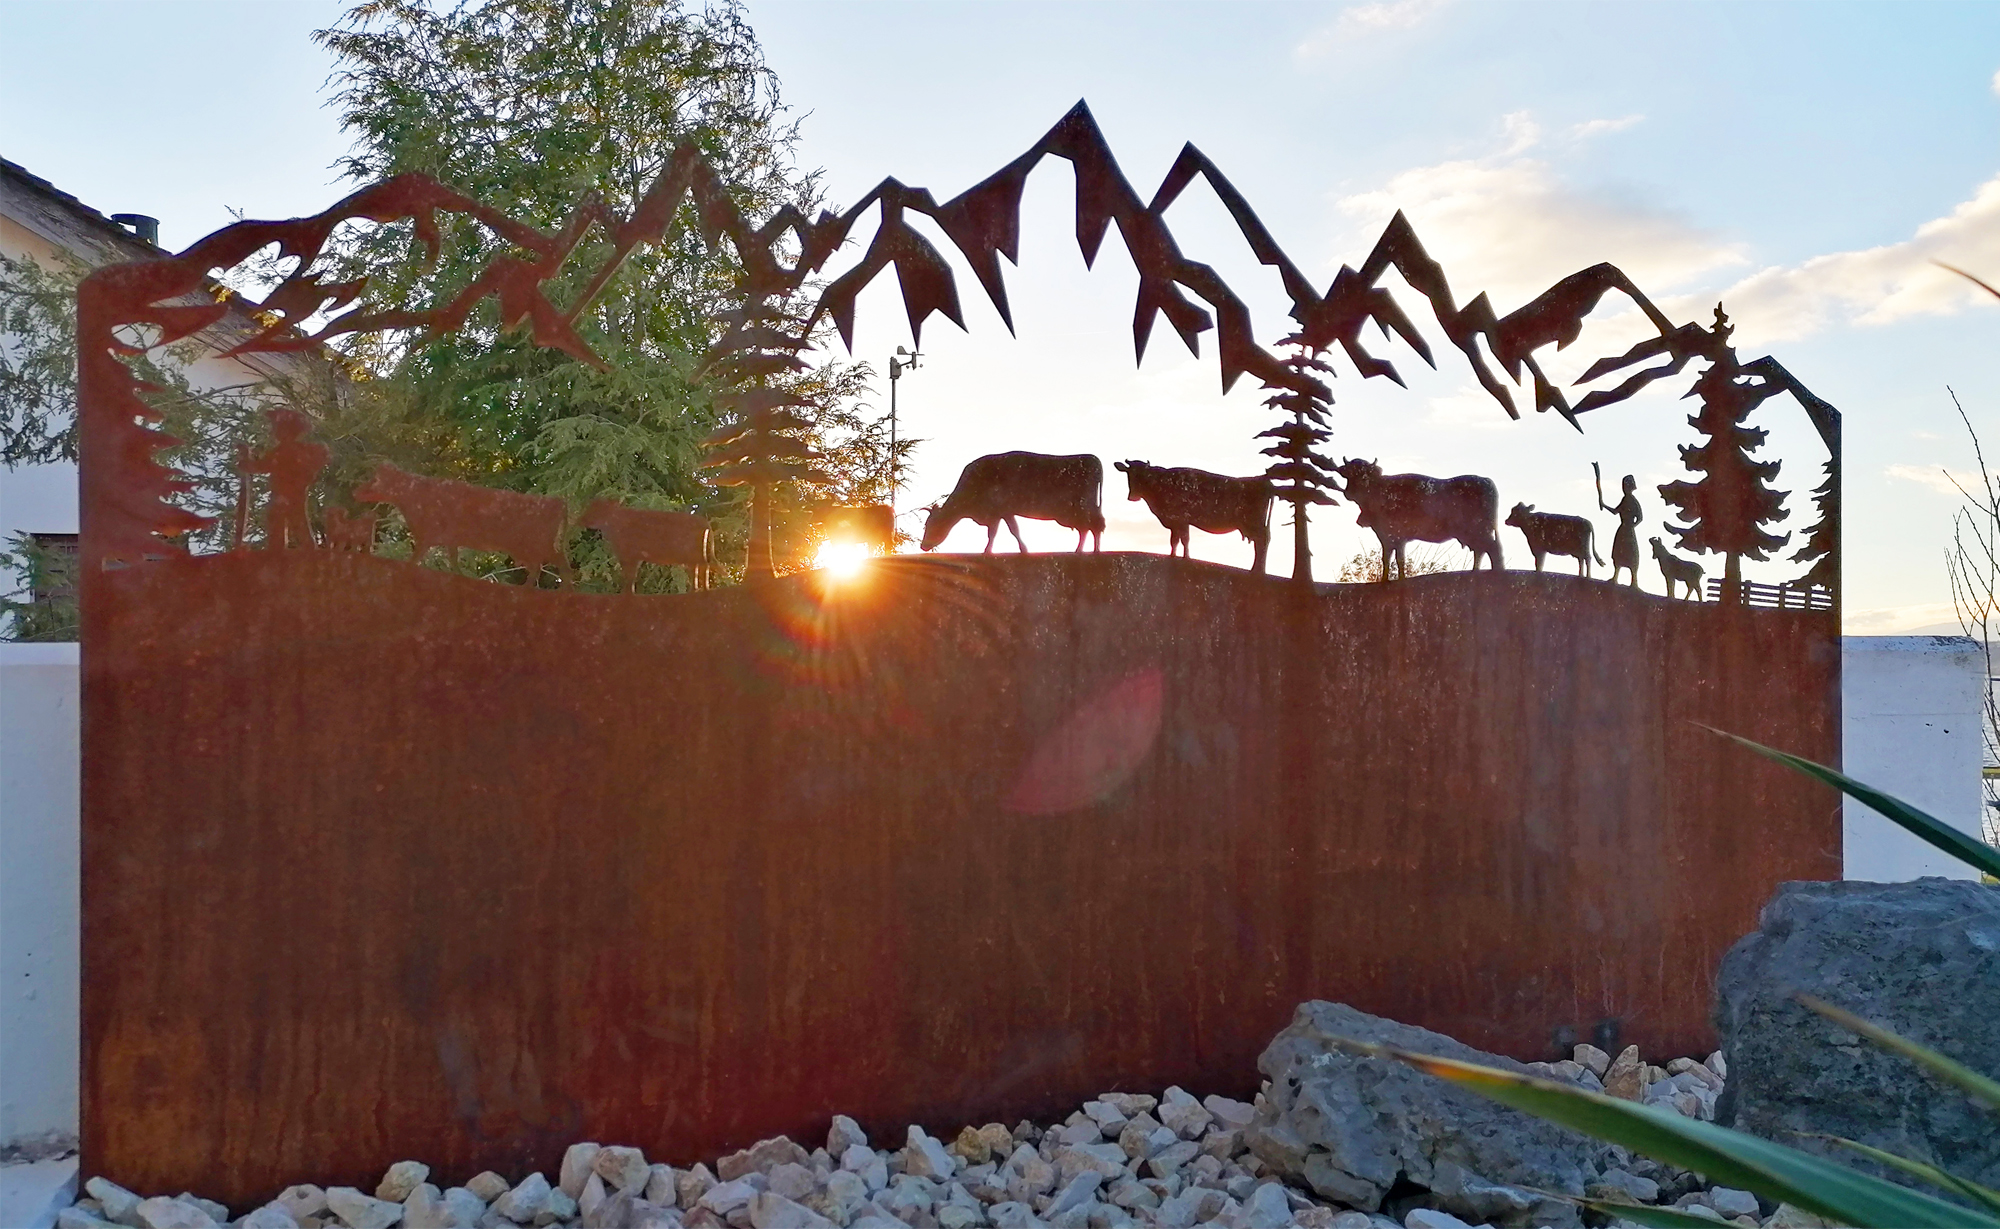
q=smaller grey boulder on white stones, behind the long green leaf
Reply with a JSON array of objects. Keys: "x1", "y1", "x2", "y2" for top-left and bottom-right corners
[{"x1": 1246, "y1": 1001, "x2": 1608, "y2": 1225}]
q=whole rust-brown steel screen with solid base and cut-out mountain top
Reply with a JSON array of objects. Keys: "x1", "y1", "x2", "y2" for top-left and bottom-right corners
[{"x1": 78, "y1": 108, "x2": 1840, "y2": 1201}]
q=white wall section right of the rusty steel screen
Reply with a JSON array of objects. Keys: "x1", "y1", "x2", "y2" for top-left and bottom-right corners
[{"x1": 1840, "y1": 637, "x2": 1986, "y2": 883}]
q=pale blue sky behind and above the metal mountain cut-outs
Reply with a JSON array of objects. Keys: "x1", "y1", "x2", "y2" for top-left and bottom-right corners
[{"x1": 0, "y1": 0, "x2": 2000, "y2": 635}]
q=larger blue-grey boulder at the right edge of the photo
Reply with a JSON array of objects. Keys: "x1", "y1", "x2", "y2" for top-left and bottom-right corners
[{"x1": 1716, "y1": 879, "x2": 2000, "y2": 1187}]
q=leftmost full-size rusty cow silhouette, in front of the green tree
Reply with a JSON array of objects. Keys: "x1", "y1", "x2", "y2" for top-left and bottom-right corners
[{"x1": 354, "y1": 460, "x2": 574, "y2": 588}]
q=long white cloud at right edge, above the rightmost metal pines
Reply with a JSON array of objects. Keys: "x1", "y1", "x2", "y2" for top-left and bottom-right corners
[{"x1": 1722, "y1": 174, "x2": 2000, "y2": 344}]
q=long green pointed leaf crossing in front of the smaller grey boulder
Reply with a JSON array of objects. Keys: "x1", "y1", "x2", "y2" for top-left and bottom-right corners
[{"x1": 1346, "y1": 1043, "x2": 2000, "y2": 1229}]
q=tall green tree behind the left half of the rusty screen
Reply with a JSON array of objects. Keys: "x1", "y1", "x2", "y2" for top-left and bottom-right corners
[{"x1": 316, "y1": 0, "x2": 892, "y2": 578}]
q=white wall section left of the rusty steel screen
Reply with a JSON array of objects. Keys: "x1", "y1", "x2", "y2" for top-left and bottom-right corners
[{"x1": 0, "y1": 643, "x2": 82, "y2": 1155}]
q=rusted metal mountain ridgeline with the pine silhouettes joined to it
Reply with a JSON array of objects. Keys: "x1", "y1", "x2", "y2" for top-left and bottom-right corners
[{"x1": 78, "y1": 104, "x2": 1838, "y2": 608}]
